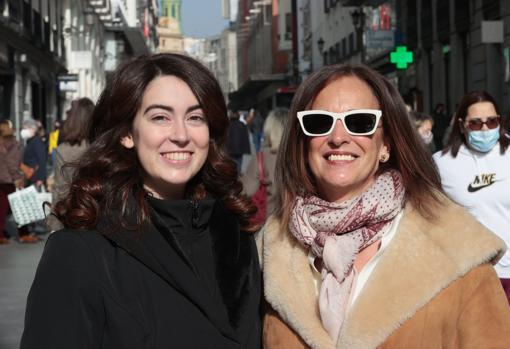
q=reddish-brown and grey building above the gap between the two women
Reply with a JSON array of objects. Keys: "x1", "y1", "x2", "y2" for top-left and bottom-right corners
[{"x1": 229, "y1": 0, "x2": 292, "y2": 114}]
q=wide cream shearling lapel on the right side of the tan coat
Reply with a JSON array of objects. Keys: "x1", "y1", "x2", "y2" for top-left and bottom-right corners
[{"x1": 337, "y1": 202, "x2": 505, "y2": 349}]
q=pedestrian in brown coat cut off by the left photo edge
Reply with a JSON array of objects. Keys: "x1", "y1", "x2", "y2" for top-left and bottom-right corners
[{"x1": 0, "y1": 120, "x2": 23, "y2": 245}]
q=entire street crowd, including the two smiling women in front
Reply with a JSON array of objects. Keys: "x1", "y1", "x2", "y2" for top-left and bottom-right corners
[{"x1": 0, "y1": 54, "x2": 510, "y2": 348}]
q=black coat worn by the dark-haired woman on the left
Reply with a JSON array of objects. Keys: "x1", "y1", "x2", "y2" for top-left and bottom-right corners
[{"x1": 21, "y1": 202, "x2": 261, "y2": 349}]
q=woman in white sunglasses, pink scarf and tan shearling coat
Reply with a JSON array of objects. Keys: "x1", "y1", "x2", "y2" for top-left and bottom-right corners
[{"x1": 261, "y1": 65, "x2": 510, "y2": 348}]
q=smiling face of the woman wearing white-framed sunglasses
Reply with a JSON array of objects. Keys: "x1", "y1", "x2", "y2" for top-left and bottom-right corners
[{"x1": 307, "y1": 76, "x2": 389, "y2": 202}]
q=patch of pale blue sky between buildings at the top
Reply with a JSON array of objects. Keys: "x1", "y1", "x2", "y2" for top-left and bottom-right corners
[{"x1": 181, "y1": 0, "x2": 228, "y2": 38}]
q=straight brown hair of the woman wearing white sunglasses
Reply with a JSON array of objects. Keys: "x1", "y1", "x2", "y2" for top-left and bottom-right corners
[{"x1": 275, "y1": 64, "x2": 442, "y2": 227}]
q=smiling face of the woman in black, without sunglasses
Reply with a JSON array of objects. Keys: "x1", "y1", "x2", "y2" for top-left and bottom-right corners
[{"x1": 121, "y1": 75, "x2": 209, "y2": 199}]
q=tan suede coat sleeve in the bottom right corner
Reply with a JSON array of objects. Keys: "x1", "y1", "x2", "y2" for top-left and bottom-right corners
[{"x1": 458, "y1": 264, "x2": 510, "y2": 349}]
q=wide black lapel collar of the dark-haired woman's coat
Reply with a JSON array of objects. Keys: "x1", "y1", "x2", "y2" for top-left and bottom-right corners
[{"x1": 104, "y1": 200, "x2": 262, "y2": 340}]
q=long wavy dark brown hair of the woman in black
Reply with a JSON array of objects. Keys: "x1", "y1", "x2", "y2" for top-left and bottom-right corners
[{"x1": 54, "y1": 54, "x2": 256, "y2": 231}]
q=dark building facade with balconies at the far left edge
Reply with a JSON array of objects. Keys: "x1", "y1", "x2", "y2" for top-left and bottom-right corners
[{"x1": 0, "y1": 0, "x2": 66, "y2": 129}]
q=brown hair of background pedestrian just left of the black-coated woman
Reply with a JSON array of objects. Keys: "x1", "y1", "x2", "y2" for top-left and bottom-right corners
[{"x1": 62, "y1": 97, "x2": 94, "y2": 145}]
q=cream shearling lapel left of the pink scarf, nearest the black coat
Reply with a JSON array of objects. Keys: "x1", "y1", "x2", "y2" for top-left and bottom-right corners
[{"x1": 262, "y1": 218, "x2": 334, "y2": 348}]
